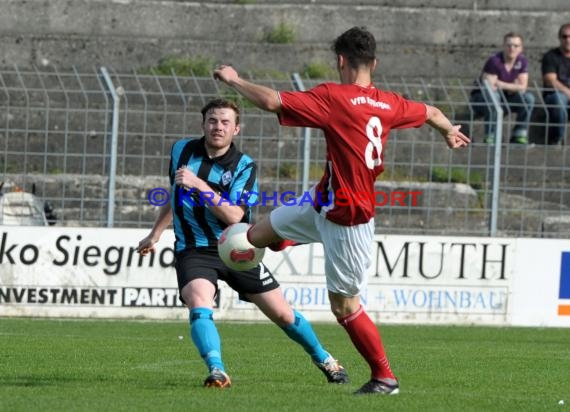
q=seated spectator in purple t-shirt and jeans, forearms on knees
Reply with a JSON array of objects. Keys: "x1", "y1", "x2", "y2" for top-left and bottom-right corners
[{"x1": 471, "y1": 32, "x2": 535, "y2": 144}]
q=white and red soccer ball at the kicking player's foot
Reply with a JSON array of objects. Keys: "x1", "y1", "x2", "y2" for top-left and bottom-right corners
[{"x1": 218, "y1": 223, "x2": 265, "y2": 271}]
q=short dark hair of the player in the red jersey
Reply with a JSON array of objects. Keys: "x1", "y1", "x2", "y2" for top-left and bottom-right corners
[{"x1": 332, "y1": 27, "x2": 376, "y2": 69}]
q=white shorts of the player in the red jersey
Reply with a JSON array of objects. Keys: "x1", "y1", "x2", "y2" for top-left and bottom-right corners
[{"x1": 269, "y1": 190, "x2": 374, "y2": 296}]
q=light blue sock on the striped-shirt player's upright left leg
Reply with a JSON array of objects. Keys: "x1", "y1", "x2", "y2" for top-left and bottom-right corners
[{"x1": 190, "y1": 308, "x2": 225, "y2": 371}]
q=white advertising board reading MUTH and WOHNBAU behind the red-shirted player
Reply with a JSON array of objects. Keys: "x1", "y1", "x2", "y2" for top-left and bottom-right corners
[{"x1": 265, "y1": 236, "x2": 514, "y2": 324}]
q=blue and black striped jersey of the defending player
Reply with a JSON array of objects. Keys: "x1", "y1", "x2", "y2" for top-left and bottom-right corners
[{"x1": 169, "y1": 137, "x2": 258, "y2": 252}]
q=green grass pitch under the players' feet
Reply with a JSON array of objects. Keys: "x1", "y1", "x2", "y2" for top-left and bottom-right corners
[{"x1": 0, "y1": 318, "x2": 570, "y2": 412}]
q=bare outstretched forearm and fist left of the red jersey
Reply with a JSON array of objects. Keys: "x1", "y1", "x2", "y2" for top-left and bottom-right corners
[{"x1": 214, "y1": 65, "x2": 281, "y2": 113}]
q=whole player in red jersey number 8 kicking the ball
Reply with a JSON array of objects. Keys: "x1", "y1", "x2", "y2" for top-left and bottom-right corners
[{"x1": 214, "y1": 27, "x2": 469, "y2": 394}]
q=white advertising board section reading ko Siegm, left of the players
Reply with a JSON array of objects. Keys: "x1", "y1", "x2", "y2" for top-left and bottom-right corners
[{"x1": 0, "y1": 226, "x2": 186, "y2": 318}]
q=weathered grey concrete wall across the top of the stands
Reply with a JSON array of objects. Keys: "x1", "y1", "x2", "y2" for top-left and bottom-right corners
[{"x1": 0, "y1": 0, "x2": 570, "y2": 80}]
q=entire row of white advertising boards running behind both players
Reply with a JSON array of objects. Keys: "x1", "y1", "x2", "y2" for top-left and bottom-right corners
[{"x1": 0, "y1": 226, "x2": 570, "y2": 327}]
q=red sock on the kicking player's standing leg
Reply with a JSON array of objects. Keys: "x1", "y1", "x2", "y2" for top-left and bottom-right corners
[{"x1": 337, "y1": 306, "x2": 396, "y2": 379}]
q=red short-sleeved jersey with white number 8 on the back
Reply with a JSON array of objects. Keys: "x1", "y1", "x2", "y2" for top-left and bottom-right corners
[{"x1": 279, "y1": 83, "x2": 427, "y2": 226}]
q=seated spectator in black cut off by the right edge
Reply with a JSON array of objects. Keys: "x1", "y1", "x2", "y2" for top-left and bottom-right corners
[{"x1": 542, "y1": 23, "x2": 570, "y2": 144}]
